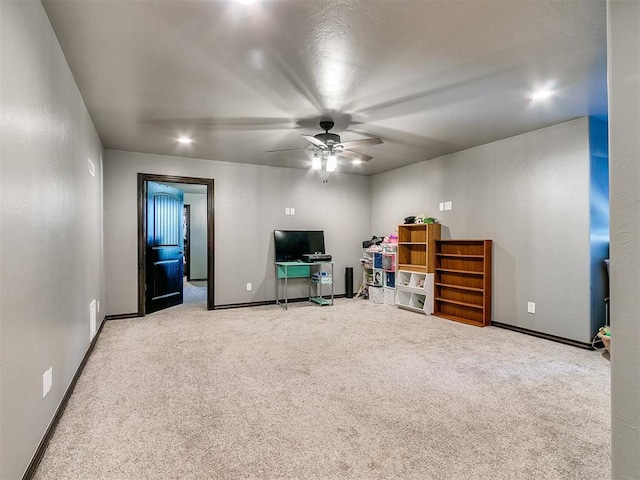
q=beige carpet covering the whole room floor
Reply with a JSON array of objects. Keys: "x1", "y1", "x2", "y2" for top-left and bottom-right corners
[{"x1": 31, "y1": 299, "x2": 611, "y2": 480}]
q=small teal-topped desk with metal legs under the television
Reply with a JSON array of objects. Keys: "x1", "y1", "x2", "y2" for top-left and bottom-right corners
[{"x1": 276, "y1": 262, "x2": 333, "y2": 310}]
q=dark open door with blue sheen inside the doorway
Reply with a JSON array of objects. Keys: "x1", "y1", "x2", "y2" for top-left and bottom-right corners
[{"x1": 145, "y1": 182, "x2": 184, "y2": 313}]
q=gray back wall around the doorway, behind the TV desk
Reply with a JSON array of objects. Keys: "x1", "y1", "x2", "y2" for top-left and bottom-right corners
[{"x1": 104, "y1": 150, "x2": 370, "y2": 315}]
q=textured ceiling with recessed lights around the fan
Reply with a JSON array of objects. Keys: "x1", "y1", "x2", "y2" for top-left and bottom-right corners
[{"x1": 43, "y1": 0, "x2": 607, "y2": 175}]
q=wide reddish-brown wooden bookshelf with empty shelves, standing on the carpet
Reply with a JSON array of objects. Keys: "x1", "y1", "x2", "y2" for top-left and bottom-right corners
[{"x1": 433, "y1": 240, "x2": 492, "y2": 327}]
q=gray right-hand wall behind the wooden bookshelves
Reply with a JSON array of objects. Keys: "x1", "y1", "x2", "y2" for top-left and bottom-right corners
[{"x1": 371, "y1": 118, "x2": 604, "y2": 342}]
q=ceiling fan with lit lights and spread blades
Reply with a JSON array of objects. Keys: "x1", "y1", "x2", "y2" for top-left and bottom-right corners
[{"x1": 269, "y1": 118, "x2": 383, "y2": 162}]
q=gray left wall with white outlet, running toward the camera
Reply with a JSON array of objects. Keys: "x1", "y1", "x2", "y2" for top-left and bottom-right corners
[{"x1": 0, "y1": 1, "x2": 104, "y2": 480}]
